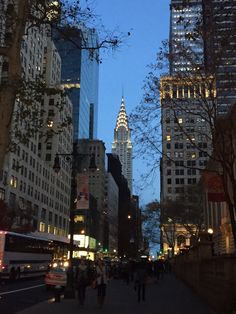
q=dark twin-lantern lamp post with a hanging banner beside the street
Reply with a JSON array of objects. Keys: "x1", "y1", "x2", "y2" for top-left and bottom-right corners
[{"x1": 53, "y1": 143, "x2": 97, "y2": 298}]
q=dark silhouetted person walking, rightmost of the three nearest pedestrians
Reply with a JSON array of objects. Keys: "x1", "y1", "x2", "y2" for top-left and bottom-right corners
[{"x1": 135, "y1": 261, "x2": 148, "y2": 302}]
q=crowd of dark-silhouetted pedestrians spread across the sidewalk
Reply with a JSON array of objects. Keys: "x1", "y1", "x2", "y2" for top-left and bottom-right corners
[{"x1": 71, "y1": 258, "x2": 171, "y2": 308}]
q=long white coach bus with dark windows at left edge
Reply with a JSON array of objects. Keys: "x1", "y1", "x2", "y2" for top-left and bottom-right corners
[{"x1": 0, "y1": 231, "x2": 68, "y2": 280}]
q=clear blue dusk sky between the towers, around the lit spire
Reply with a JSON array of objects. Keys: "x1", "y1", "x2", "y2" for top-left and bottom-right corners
[{"x1": 95, "y1": 0, "x2": 170, "y2": 204}]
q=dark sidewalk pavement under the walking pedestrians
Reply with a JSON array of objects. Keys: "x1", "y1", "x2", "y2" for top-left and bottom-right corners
[{"x1": 17, "y1": 275, "x2": 214, "y2": 314}]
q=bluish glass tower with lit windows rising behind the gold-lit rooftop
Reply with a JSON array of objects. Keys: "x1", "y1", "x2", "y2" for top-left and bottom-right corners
[{"x1": 169, "y1": 0, "x2": 203, "y2": 75}]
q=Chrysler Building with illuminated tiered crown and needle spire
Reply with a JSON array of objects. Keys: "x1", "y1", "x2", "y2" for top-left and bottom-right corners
[{"x1": 112, "y1": 96, "x2": 133, "y2": 195}]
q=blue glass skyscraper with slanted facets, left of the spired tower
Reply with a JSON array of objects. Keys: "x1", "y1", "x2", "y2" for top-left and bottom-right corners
[{"x1": 53, "y1": 25, "x2": 99, "y2": 141}]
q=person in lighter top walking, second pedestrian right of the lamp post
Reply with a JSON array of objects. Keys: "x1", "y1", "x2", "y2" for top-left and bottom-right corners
[{"x1": 96, "y1": 259, "x2": 107, "y2": 308}]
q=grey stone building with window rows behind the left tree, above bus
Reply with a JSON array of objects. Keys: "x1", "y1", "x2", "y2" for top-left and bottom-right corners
[{"x1": 0, "y1": 3, "x2": 73, "y2": 241}]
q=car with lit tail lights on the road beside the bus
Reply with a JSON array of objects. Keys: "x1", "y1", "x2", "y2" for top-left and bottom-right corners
[{"x1": 45, "y1": 267, "x2": 67, "y2": 290}]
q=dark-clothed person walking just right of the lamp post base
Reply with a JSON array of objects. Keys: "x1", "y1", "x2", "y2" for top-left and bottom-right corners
[{"x1": 76, "y1": 258, "x2": 89, "y2": 306}]
